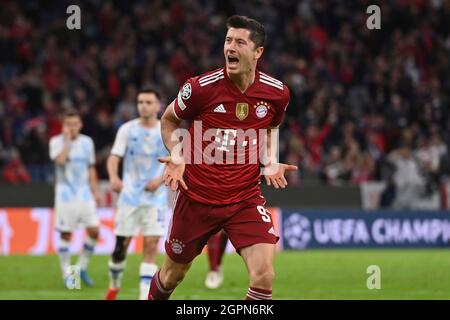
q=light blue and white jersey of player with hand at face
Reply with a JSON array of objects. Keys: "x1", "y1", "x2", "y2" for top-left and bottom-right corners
[{"x1": 50, "y1": 134, "x2": 95, "y2": 203}]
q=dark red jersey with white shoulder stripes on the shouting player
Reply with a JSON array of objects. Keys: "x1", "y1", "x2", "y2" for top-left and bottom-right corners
[{"x1": 174, "y1": 68, "x2": 289, "y2": 205}]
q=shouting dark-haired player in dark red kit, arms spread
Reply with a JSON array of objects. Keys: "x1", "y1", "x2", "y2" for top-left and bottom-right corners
[{"x1": 148, "y1": 16, "x2": 297, "y2": 300}]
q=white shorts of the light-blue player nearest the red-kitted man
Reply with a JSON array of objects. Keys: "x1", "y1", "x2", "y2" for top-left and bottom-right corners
[{"x1": 114, "y1": 206, "x2": 165, "y2": 237}]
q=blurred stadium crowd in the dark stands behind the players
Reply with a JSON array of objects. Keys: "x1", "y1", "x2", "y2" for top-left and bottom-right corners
[{"x1": 0, "y1": 0, "x2": 450, "y2": 195}]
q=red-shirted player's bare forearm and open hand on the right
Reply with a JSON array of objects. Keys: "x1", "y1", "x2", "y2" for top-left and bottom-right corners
[{"x1": 264, "y1": 128, "x2": 298, "y2": 189}]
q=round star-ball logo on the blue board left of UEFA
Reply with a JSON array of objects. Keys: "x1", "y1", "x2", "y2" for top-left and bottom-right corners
[{"x1": 283, "y1": 213, "x2": 311, "y2": 249}]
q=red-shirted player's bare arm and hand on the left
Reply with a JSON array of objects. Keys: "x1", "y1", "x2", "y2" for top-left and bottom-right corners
[{"x1": 159, "y1": 102, "x2": 187, "y2": 191}]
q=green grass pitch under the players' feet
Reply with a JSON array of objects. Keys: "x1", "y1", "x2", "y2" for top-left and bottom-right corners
[{"x1": 0, "y1": 249, "x2": 450, "y2": 300}]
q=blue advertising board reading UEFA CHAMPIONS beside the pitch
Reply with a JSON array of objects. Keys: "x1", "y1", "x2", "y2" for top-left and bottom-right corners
[{"x1": 281, "y1": 209, "x2": 450, "y2": 250}]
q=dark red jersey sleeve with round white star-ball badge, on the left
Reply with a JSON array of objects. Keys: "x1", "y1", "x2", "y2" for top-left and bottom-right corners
[{"x1": 174, "y1": 78, "x2": 204, "y2": 120}]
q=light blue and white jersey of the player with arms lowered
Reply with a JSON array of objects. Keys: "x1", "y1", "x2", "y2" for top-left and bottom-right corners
[{"x1": 111, "y1": 119, "x2": 168, "y2": 207}]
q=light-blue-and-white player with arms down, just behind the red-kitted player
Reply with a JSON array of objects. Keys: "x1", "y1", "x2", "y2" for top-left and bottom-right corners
[{"x1": 106, "y1": 89, "x2": 167, "y2": 300}]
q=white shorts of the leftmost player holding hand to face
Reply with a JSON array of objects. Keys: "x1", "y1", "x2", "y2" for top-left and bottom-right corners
[{"x1": 55, "y1": 201, "x2": 100, "y2": 232}]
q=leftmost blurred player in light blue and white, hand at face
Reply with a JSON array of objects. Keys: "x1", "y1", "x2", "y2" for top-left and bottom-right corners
[{"x1": 50, "y1": 110, "x2": 99, "y2": 286}]
